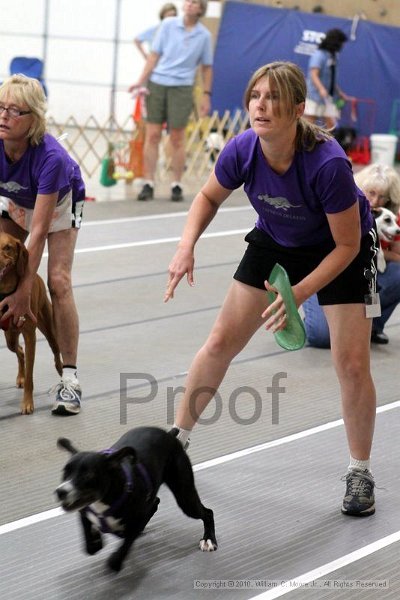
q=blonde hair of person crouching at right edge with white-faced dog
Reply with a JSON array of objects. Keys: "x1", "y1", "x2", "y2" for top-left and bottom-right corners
[{"x1": 354, "y1": 163, "x2": 400, "y2": 212}]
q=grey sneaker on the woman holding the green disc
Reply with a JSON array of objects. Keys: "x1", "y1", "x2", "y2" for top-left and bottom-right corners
[{"x1": 342, "y1": 469, "x2": 375, "y2": 517}]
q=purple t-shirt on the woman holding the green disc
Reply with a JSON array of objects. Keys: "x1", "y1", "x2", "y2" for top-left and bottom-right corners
[{"x1": 215, "y1": 129, "x2": 372, "y2": 247}]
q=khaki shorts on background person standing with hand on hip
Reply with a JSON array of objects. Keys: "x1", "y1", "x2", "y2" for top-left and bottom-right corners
[{"x1": 146, "y1": 81, "x2": 193, "y2": 129}]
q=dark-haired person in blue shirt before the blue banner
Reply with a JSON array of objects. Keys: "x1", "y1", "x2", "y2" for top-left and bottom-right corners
[{"x1": 304, "y1": 29, "x2": 351, "y2": 129}]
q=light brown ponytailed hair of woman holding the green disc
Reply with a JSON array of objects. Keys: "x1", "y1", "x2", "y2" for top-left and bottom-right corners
[{"x1": 244, "y1": 61, "x2": 332, "y2": 151}]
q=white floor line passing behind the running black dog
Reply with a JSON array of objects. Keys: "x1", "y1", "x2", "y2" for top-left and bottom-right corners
[{"x1": 0, "y1": 401, "x2": 400, "y2": 536}]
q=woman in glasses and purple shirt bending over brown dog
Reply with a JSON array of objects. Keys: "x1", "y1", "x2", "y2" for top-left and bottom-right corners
[{"x1": 0, "y1": 75, "x2": 85, "y2": 415}]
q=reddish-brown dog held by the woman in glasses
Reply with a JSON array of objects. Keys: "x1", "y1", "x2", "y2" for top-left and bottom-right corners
[{"x1": 0, "y1": 232, "x2": 62, "y2": 415}]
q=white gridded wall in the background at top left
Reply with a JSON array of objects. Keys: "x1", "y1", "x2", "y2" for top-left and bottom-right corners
[{"x1": 0, "y1": 0, "x2": 219, "y2": 124}]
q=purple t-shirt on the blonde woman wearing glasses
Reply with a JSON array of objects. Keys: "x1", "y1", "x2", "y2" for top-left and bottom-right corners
[{"x1": 0, "y1": 133, "x2": 85, "y2": 208}]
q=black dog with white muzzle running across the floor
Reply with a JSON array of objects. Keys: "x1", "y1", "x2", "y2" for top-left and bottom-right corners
[{"x1": 55, "y1": 427, "x2": 217, "y2": 572}]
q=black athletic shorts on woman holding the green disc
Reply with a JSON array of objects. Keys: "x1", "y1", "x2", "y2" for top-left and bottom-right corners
[{"x1": 233, "y1": 227, "x2": 378, "y2": 305}]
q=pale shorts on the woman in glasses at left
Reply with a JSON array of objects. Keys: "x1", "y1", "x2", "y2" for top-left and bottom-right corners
[{"x1": 0, "y1": 192, "x2": 84, "y2": 233}]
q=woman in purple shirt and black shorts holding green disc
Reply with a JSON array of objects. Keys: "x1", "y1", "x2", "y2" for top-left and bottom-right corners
[{"x1": 165, "y1": 62, "x2": 376, "y2": 516}]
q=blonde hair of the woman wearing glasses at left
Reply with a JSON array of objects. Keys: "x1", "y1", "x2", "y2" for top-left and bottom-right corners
[{"x1": 0, "y1": 74, "x2": 47, "y2": 146}]
